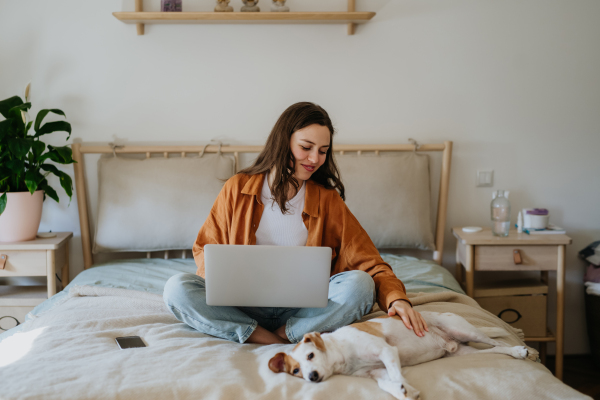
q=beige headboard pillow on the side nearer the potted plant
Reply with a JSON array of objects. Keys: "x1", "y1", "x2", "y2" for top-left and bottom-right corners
[{"x1": 93, "y1": 154, "x2": 235, "y2": 253}]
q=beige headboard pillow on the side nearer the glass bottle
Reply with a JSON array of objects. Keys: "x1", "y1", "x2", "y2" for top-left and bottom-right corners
[{"x1": 336, "y1": 152, "x2": 435, "y2": 250}]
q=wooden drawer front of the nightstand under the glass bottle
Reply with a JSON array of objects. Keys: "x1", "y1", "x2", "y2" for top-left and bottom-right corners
[{"x1": 473, "y1": 245, "x2": 558, "y2": 271}]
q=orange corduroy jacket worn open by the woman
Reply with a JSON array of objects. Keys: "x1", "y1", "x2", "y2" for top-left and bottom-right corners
[{"x1": 193, "y1": 174, "x2": 410, "y2": 310}]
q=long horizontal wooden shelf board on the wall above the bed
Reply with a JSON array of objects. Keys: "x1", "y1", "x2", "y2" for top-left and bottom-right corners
[{"x1": 113, "y1": 11, "x2": 375, "y2": 24}]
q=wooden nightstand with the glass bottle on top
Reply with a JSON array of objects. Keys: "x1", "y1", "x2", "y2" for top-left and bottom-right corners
[{"x1": 452, "y1": 227, "x2": 571, "y2": 380}]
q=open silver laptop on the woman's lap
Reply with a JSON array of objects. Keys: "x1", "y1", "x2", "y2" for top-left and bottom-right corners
[{"x1": 204, "y1": 244, "x2": 331, "y2": 308}]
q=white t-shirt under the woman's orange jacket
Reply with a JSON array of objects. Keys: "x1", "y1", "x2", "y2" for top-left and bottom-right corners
[{"x1": 256, "y1": 174, "x2": 308, "y2": 246}]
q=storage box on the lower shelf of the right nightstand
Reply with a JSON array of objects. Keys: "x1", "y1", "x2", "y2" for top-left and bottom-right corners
[{"x1": 474, "y1": 280, "x2": 548, "y2": 338}]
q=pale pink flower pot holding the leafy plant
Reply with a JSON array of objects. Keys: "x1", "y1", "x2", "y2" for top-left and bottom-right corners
[{"x1": 0, "y1": 190, "x2": 44, "y2": 242}]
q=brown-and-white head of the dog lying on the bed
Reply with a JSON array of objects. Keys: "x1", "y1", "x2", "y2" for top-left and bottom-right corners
[{"x1": 269, "y1": 332, "x2": 333, "y2": 382}]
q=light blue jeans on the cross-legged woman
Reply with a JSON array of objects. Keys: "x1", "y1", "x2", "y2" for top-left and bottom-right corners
[{"x1": 163, "y1": 271, "x2": 375, "y2": 343}]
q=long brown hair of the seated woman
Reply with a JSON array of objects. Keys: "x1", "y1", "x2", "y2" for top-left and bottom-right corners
[{"x1": 239, "y1": 102, "x2": 346, "y2": 214}]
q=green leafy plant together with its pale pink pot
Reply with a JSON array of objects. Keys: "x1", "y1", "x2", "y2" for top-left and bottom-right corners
[{"x1": 0, "y1": 86, "x2": 75, "y2": 242}]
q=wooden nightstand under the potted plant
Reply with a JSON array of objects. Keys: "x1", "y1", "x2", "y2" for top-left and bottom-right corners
[{"x1": 0, "y1": 232, "x2": 73, "y2": 332}]
